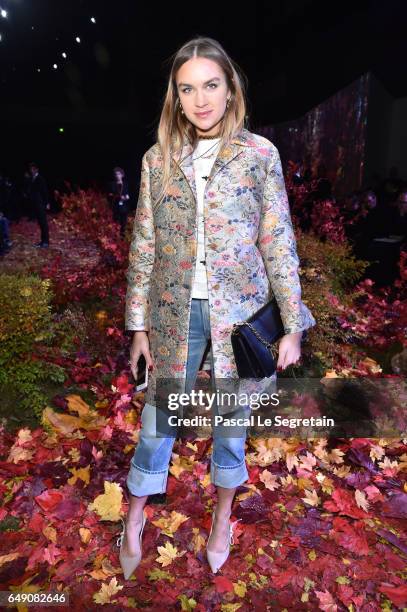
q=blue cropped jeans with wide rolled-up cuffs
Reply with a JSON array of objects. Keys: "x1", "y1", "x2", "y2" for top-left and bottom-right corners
[{"x1": 127, "y1": 298, "x2": 249, "y2": 497}]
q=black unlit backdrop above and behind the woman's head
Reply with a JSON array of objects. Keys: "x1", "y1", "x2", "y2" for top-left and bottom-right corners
[{"x1": 0, "y1": 0, "x2": 407, "y2": 188}]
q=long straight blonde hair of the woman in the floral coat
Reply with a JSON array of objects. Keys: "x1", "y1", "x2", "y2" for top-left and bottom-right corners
[{"x1": 156, "y1": 36, "x2": 247, "y2": 203}]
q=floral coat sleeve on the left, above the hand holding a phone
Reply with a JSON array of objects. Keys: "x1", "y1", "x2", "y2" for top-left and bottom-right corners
[{"x1": 125, "y1": 153, "x2": 155, "y2": 331}]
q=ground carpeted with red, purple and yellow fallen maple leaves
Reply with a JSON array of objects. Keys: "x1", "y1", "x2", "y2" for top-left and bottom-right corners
[{"x1": 0, "y1": 219, "x2": 407, "y2": 612}]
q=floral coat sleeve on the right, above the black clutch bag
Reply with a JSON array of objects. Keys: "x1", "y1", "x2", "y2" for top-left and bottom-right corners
[{"x1": 257, "y1": 145, "x2": 316, "y2": 334}]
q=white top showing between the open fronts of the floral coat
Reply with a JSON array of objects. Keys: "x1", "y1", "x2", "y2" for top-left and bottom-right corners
[{"x1": 192, "y1": 138, "x2": 220, "y2": 300}]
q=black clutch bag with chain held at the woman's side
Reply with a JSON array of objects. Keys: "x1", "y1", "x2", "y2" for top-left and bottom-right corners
[{"x1": 231, "y1": 298, "x2": 285, "y2": 378}]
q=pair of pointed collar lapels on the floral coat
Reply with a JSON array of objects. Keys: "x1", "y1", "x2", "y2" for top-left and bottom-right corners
[{"x1": 172, "y1": 128, "x2": 255, "y2": 201}]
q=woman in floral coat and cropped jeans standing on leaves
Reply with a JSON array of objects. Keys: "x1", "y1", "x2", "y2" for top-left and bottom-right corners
[{"x1": 120, "y1": 37, "x2": 315, "y2": 578}]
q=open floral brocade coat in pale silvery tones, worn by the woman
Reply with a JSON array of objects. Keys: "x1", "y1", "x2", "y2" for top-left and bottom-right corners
[{"x1": 125, "y1": 128, "x2": 316, "y2": 405}]
